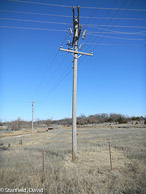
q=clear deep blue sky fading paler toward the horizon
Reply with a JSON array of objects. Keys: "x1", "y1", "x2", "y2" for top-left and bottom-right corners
[{"x1": 0, "y1": 0, "x2": 146, "y2": 121}]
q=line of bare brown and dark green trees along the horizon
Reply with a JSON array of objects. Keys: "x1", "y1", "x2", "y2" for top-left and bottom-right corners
[{"x1": 0, "y1": 113, "x2": 146, "y2": 130}]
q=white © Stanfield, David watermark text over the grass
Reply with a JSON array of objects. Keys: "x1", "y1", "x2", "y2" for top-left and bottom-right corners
[{"x1": 0, "y1": 188, "x2": 44, "y2": 193}]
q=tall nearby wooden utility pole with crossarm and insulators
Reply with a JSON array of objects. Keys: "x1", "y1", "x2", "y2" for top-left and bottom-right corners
[{"x1": 59, "y1": 6, "x2": 93, "y2": 161}]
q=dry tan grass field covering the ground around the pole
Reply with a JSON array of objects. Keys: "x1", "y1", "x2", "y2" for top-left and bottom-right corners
[{"x1": 0, "y1": 125, "x2": 146, "y2": 194}]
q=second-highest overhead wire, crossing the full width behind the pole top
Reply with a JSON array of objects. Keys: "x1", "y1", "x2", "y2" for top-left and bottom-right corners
[{"x1": 0, "y1": 10, "x2": 146, "y2": 20}]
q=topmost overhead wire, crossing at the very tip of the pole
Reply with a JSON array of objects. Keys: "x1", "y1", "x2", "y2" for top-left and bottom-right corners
[{"x1": 9, "y1": 0, "x2": 146, "y2": 12}]
